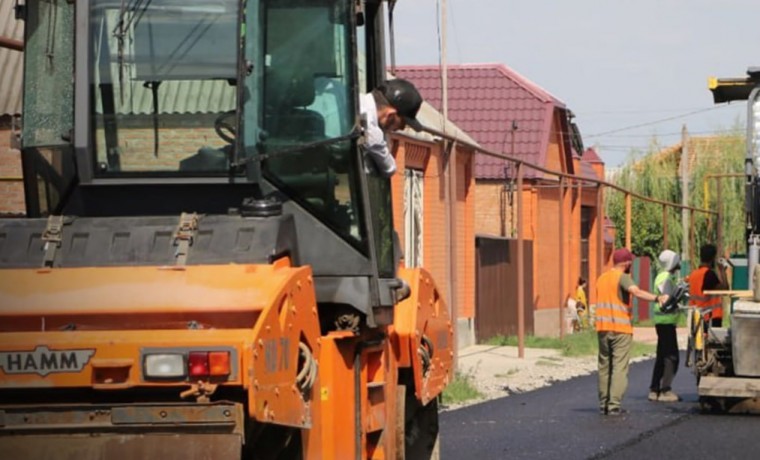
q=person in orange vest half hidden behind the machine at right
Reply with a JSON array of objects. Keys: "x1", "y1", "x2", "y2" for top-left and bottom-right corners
[{"x1": 687, "y1": 244, "x2": 728, "y2": 327}]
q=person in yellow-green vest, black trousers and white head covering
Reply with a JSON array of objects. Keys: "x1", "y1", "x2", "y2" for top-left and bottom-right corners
[{"x1": 647, "y1": 249, "x2": 681, "y2": 402}]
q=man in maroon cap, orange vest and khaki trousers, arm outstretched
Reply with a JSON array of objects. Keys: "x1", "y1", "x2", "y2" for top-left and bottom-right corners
[{"x1": 596, "y1": 248, "x2": 668, "y2": 415}]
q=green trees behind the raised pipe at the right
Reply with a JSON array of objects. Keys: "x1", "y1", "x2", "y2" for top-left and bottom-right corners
[{"x1": 606, "y1": 129, "x2": 745, "y2": 259}]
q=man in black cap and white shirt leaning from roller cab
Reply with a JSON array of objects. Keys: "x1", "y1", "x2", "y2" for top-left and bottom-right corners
[{"x1": 359, "y1": 78, "x2": 422, "y2": 177}]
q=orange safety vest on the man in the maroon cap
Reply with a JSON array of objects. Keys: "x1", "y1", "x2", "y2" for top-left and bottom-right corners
[{"x1": 596, "y1": 269, "x2": 633, "y2": 334}]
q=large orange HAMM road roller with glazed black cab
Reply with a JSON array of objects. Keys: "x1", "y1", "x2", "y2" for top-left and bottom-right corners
[{"x1": 0, "y1": 0, "x2": 453, "y2": 459}]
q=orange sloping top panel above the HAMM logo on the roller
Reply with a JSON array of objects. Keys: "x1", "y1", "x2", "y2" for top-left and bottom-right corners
[{"x1": 0, "y1": 264, "x2": 294, "y2": 315}]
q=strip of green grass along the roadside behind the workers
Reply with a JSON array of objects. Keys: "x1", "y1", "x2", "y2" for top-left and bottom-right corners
[{"x1": 484, "y1": 331, "x2": 656, "y2": 358}]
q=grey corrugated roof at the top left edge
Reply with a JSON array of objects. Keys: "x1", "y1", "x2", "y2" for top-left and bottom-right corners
[{"x1": 0, "y1": 0, "x2": 24, "y2": 116}]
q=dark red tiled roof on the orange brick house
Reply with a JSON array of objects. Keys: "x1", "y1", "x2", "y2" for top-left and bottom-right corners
[{"x1": 396, "y1": 64, "x2": 569, "y2": 179}]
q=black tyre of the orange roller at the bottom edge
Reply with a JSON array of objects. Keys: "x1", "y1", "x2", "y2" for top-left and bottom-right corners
[{"x1": 396, "y1": 385, "x2": 441, "y2": 460}]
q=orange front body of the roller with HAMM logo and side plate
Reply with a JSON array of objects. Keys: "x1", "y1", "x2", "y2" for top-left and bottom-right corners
[{"x1": 0, "y1": 264, "x2": 319, "y2": 428}]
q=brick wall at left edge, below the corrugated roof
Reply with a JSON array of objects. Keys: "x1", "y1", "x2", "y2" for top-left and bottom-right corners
[{"x1": 0, "y1": 116, "x2": 26, "y2": 215}]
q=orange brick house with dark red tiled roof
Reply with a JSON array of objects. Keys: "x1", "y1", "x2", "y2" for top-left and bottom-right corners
[{"x1": 397, "y1": 64, "x2": 614, "y2": 339}]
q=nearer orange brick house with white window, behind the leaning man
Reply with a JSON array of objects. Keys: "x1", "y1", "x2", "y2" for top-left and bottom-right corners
[{"x1": 391, "y1": 103, "x2": 477, "y2": 346}]
